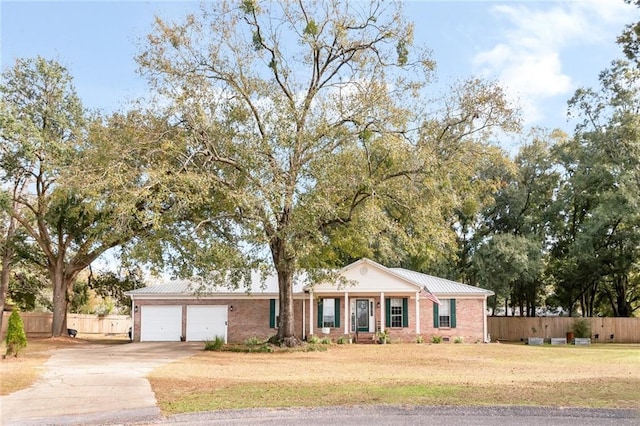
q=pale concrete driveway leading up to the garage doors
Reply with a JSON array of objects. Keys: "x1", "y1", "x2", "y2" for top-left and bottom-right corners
[{"x1": 0, "y1": 342, "x2": 203, "y2": 425}]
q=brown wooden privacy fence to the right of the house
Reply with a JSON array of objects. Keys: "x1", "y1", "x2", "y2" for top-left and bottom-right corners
[{"x1": 487, "y1": 317, "x2": 640, "y2": 343}]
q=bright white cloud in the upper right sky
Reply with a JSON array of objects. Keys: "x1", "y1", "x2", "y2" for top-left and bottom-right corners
[{"x1": 473, "y1": 0, "x2": 637, "y2": 124}]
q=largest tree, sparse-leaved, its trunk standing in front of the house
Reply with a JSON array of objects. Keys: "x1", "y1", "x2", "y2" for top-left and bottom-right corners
[{"x1": 139, "y1": 0, "x2": 513, "y2": 345}]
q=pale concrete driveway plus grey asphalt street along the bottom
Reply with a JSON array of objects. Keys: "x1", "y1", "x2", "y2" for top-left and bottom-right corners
[{"x1": 0, "y1": 343, "x2": 640, "y2": 426}]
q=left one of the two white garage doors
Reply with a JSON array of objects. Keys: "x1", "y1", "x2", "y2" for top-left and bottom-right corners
[{"x1": 140, "y1": 306, "x2": 182, "y2": 342}]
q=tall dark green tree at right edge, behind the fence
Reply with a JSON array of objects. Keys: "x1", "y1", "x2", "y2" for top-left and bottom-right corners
[{"x1": 552, "y1": 61, "x2": 640, "y2": 316}]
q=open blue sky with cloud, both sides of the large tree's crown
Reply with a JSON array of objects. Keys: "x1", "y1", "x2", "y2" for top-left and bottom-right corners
[{"x1": 0, "y1": 0, "x2": 640, "y2": 138}]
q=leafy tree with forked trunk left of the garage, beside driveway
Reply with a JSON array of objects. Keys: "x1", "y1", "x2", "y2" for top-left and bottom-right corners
[{"x1": 0, "y1": 57, "x2": 155, "y2": 336}]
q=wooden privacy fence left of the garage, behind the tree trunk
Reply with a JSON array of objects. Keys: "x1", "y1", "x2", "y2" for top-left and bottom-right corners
[{"x1": 2, "y1": 312, "x2": 131, "y2": 337}]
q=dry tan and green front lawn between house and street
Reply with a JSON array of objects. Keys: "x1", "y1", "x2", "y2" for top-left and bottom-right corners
[{"x1": 150, "y1": 344, "x2": 640, "y2": 414}]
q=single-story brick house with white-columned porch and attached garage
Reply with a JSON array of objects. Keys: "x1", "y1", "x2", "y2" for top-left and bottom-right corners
[{"x1": 126, "y1": 259, "x2": 493, "y2": 343}]
